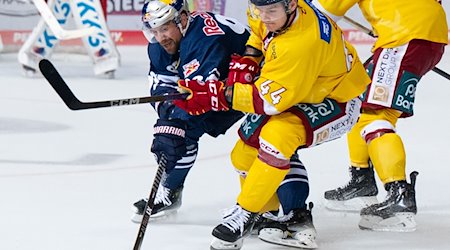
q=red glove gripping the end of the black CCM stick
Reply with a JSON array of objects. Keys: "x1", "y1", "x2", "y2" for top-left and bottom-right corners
[{"x1": 173, "y1": 79, "x2": 230, "y2": 115}]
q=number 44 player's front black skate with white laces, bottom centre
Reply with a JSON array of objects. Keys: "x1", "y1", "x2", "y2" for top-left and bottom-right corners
[{"x1": 210, "y1": 205, "x2": 259, "y2": 250}]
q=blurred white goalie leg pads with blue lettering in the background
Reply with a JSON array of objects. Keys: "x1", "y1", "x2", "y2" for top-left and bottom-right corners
[{"x1": 18, "y1": 0, "x2": 120, "y2": 78}]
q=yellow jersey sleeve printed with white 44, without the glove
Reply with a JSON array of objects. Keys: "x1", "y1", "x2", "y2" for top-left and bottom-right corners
[{"x1": 229, "y1": 41, "x2": 326, "y2": 115}]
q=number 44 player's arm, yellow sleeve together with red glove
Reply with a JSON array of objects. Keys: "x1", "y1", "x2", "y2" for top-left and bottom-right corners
[{"x1": 175, "y1": 41, "x2": 325, "y2": 115}]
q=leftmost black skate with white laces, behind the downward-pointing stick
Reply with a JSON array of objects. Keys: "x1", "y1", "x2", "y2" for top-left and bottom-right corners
[{"x1": 131, "y1": 185, "x2": 183, "y2": 223}]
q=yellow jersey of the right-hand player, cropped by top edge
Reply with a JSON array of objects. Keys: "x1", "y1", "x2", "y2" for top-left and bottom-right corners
[{"x1": 314, "y1": 0, "x2": 448, "y2": 50}]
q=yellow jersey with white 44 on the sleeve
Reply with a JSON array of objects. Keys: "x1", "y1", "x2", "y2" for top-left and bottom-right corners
[{"x1": 232, "y1": 1, "x2": 370, "y2": 115}]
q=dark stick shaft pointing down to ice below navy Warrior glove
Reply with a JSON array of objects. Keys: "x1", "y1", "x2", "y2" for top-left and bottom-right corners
[{"x1": 133, "y1": 154, "x2": 167, "y2": 250}]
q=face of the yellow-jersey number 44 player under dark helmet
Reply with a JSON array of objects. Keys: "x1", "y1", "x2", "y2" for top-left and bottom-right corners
[{"x1": 254, "y1": 2, "x2": 287, "y2": 32}]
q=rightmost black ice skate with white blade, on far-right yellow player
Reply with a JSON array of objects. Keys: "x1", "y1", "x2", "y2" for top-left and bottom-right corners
[{"x1": 359, "y1": 171, "x2": 419, "y2": 232}]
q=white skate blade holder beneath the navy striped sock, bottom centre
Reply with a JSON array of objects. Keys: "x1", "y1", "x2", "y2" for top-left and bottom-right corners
[{"x1": 258, "y1": 228, "x2": 318, "y2": 249}]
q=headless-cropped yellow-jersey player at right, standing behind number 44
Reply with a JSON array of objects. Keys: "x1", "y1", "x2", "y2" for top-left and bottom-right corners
[{"x1": 313, "y1": 0, "x2": 448, "y2": 232}]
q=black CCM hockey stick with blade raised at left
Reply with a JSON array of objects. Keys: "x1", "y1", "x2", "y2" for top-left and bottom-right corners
[{"x1": 39, "y1": 59, "x2": 189, "y2": 110}]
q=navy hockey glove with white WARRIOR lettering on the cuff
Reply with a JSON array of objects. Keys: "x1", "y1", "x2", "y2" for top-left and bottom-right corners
[{"x1": 151, "y1": 119, "x2": 186, "y2": 173}]
